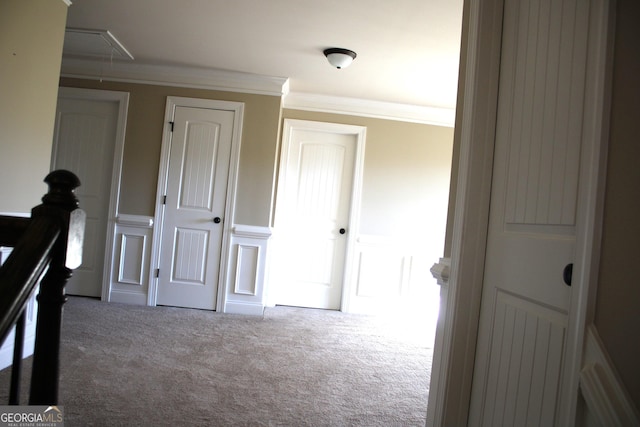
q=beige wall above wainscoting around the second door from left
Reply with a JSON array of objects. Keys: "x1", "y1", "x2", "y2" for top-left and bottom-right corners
[{"x1": 60, "y1": 78, "x2": 281, "y2": 226}]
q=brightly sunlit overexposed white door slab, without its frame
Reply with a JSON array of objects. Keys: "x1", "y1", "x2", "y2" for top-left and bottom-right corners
[{"x1": 276, "y1": 122, "x2": 358, "y2": 310}]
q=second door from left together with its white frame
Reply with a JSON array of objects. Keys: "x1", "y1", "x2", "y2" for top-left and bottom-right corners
[{"x1": 149, "y1": 97, "x2": 244, "y2": 311}]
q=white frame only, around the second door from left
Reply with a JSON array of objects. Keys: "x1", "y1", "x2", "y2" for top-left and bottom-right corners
[{"x1": 147, "y1": 96, "x2": 244, "y2": 312}]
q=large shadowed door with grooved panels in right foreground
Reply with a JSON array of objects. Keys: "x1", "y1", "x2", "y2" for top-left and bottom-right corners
[{"x1": 469, "y1": 0, "x2": 590, "y2": 426}]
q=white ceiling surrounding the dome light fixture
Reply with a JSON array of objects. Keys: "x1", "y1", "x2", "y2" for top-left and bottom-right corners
[{"x1": 63, "y1": 0, "x2": 463, "y2": 123}]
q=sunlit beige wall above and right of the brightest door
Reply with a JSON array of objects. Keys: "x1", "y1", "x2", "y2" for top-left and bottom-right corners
[{"x1": 282, "y1": 109, "x2": 453, "y2": 251}]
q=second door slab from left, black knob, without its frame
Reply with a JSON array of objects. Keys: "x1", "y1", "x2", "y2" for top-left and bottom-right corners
[{"x1": 157, "y1": 107, "x2": 234, "y2": 310}]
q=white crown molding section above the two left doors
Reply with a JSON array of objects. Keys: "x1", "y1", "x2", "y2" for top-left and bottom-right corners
[{"x1": 60, "y1": 57, "x2": 289, "y2": 96}]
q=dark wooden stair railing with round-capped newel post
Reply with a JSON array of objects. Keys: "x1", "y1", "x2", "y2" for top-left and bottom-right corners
[{"x1": 0, "y1": 170, "x2": 86, "y2": 405}]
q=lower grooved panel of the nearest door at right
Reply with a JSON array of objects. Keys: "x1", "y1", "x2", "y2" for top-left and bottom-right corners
[{"x1": 481, "y1": 292, "x2": 566, "y2": 426}]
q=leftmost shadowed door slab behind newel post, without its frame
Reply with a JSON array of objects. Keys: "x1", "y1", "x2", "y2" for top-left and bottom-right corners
[{"x1": 51, "y1": 97, "x2": 119, "y2": 297}]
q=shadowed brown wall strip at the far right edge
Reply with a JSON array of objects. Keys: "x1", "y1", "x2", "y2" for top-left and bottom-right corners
[{"x1": 595, "y1": 0, "x2": 640, "y2": 408}]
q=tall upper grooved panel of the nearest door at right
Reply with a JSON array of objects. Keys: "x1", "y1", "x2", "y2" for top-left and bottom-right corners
[{"x1": 498, "y1": 0, "x2": 588, "y2": 225}]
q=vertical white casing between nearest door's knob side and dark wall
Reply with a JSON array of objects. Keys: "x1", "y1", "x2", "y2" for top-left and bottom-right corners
[{"x1": 557, "y1": 0, "x2": 615, "y2": 425}]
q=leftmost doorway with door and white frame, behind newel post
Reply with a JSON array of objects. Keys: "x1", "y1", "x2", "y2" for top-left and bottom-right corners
[{"x1": 51, "y1": 87, "x2": 129, "y2": 297}]
